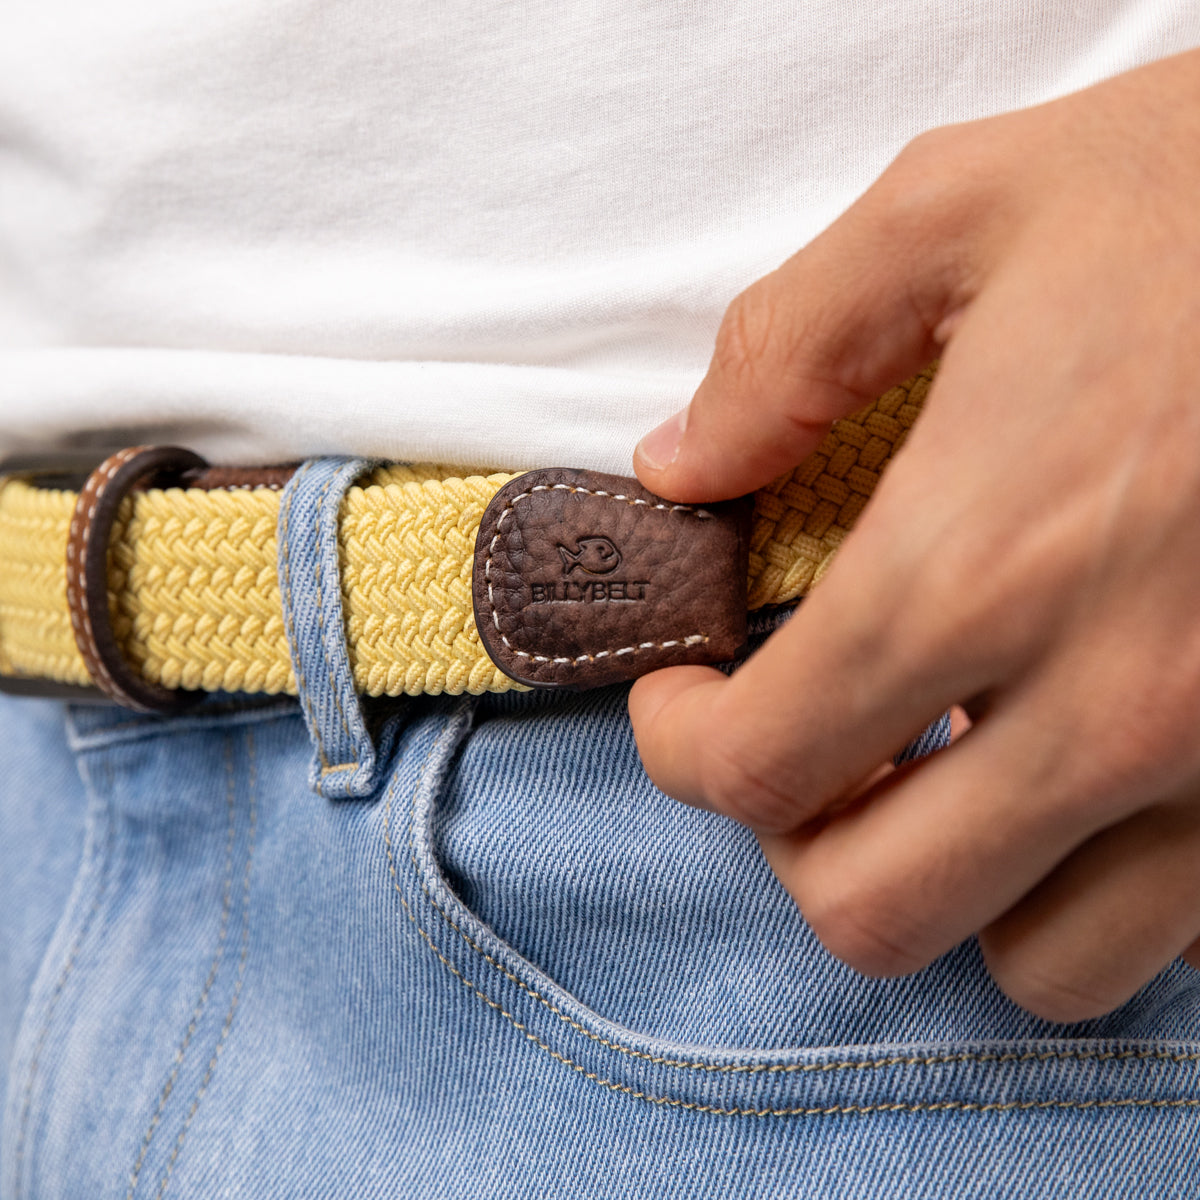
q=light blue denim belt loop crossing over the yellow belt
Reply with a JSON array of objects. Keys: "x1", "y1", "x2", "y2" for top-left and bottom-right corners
[{"x1": 278, "y1": 458, "x2": 378, "y2": 799}]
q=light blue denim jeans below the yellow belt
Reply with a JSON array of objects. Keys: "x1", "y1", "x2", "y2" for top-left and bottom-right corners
[{"x1": 0, "y1": 463, "x2": 1200, "y2": 1200}]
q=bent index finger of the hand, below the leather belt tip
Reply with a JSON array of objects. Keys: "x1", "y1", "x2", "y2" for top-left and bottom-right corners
[{"x1": 629, "y1": 412, "x2": 992, "y2": 833}]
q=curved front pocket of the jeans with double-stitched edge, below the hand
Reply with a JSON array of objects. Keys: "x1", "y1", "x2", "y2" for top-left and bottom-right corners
[{"x1": 398, "y1": 689, "x2": 1200, "y2": 1117}]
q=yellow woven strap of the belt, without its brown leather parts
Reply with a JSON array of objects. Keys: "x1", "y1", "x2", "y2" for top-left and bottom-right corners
[{"x1": 0, "y1": 371, "x2": 932, "y2": 696}]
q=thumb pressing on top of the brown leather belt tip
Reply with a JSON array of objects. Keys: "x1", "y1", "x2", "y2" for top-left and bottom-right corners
[{"x1": 634, "y1": 127, "x2": 994, "y2": 503}]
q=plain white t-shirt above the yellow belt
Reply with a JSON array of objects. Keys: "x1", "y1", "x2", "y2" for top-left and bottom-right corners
[{"x1": 0, "y1": 0, "x2": 1200, "y2": 473}]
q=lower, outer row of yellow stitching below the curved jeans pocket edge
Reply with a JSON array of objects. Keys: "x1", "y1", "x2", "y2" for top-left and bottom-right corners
[{"x1": 384, "y1": 736, "x2": 1200, "y2": 1117}]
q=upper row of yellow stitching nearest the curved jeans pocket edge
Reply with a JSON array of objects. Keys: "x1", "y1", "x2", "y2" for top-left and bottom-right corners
[{"x1": 398, "y1": 710, "x2": 1200, "y2": 1075}]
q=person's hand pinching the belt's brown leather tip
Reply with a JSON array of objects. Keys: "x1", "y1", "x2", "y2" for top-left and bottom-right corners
[{"x1": 629, "y1": 52, "x2": 1200, "y2": 1021}]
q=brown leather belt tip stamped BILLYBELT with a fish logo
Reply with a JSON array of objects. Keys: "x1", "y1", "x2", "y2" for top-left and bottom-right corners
[{"x1": 473, "y1": 467, "x2": 751, "y2": 688}]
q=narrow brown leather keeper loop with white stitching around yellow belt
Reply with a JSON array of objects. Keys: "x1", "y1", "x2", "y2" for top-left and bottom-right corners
[{"x1": 67, "y1": 446, "x2": 208, "y2": 713}]
